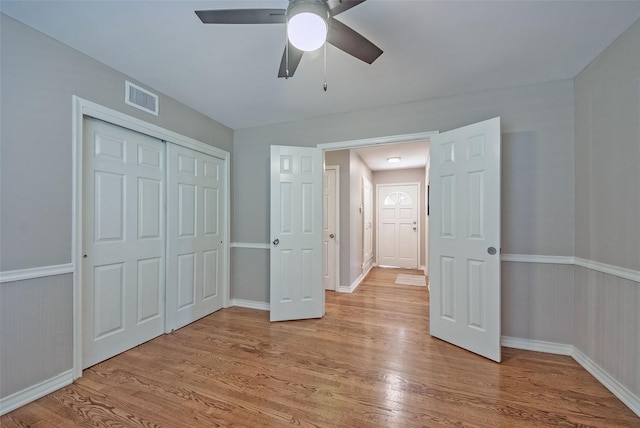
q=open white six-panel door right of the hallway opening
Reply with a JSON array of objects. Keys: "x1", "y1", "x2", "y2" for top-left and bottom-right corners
[{"x1": 429, "y1": 118, "x2": 500, "y2": 362}]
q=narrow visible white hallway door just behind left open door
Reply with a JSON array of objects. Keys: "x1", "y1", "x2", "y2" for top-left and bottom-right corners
[{"x1": 322, "y1": 166, "x2": 338, "y2": 290}]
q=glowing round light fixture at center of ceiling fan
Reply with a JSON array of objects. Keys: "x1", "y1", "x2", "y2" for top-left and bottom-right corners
[{"x1": 287, "y1": 1, "x2": 329, "y2": 52}]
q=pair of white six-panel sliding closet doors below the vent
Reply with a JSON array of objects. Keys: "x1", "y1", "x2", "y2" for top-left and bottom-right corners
[{"x1": 82, "y1": 118, "x2": 227, "y2": 368}]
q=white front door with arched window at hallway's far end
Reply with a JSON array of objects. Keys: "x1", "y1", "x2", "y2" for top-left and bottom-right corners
[{"x1": 377, "y1": 183, "x2": 419, "y2": 269}]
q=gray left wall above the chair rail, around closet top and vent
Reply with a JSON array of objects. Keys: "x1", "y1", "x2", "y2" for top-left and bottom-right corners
[{"x1": 0, "y1": 15, "x2": 233, "y2": 271}]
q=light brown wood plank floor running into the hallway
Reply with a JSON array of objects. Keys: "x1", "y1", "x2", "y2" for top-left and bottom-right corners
[{"x1": 0, "y1": 269, "x2": 640, "y2": 428}]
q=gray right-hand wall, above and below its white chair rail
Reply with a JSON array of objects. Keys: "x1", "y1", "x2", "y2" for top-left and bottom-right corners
[{"x1": 573, "y1": 17, "x2": 640, "y2": 400}]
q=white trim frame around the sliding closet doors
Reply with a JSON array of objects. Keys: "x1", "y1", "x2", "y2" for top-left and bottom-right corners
[{"x1": 71, "y1": 95, "x2": 231, "y2": 379}]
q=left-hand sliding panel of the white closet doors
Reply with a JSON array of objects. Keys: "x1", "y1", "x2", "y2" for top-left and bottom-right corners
[{"x1": 82, "y1": 118, "x2": 165, "y2": 368}]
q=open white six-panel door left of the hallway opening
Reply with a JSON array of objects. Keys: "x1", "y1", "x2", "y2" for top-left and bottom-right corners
[{"x1": 270, "y1": 146, "x2": 324, "y2": 321}]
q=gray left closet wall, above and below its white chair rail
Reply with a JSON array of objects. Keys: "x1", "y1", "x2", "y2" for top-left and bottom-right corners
[{"x1": 0, "y1": 14, "x2": 233, "y2": 398}]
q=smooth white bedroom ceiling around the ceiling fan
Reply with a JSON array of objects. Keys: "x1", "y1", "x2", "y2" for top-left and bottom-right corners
[{"x1": 0, "y1": 0, "x2": 640, "y2": 129}]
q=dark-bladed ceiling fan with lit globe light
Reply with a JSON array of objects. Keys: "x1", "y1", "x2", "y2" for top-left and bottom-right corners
[{"x1": 195, "y1": 0, "x2": 382, "y2": 78}]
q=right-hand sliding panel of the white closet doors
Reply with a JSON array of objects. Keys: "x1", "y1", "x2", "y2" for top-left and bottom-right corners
[{"x1": 166, "y1": 143, "x2": 226, "y2": 331}]
